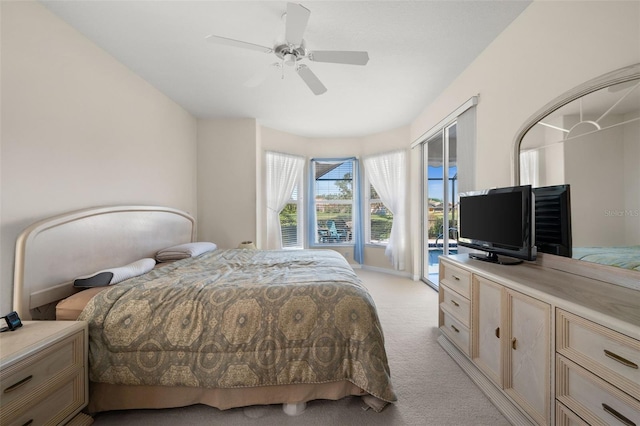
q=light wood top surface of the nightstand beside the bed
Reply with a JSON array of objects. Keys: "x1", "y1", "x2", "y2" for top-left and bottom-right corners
[{"x1": 0, "y1": 321, "x2": 86, "y2": 368}]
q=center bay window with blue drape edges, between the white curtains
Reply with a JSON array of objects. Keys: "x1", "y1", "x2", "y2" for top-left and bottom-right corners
[{"x1": 311, "y1": 159, "x2": 354, "y2": 244}]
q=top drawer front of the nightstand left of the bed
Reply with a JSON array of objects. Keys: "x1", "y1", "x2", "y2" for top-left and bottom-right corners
[{"x1": 0, "y1": 331, "x2": 84, "y2": 407}]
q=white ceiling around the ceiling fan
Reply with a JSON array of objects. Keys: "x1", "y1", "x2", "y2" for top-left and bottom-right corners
[{"x1": 42, "y1": 0, "x2": 530, "y2": 137}]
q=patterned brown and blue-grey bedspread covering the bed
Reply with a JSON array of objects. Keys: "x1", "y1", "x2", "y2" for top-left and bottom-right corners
[{"x1": 79, "y1": 250, "x2": 396, "y2": 410}]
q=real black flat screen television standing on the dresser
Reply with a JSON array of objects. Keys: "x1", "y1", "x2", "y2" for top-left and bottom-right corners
[{"x1": 458, "y1": 185, "x2": 536, "y2": 264}]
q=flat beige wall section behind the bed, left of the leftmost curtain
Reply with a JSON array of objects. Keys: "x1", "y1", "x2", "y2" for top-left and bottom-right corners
[{"x1": 197, "y1": 118, "x2": 257, "y2": 248}]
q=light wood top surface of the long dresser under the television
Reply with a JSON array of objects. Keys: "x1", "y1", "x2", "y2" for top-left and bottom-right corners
[{"x1": 442, "y1": 254, "x2": 640, "y2": 339}]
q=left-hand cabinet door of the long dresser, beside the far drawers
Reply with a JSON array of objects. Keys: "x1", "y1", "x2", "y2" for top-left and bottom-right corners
[{"x1": 472, "y1": 276, "x2": 503, "y2": 387}]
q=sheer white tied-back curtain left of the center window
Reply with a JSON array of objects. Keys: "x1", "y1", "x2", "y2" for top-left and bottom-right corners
[{"x1": 266, "y1": 152, "x2": 304, "y2": 249}]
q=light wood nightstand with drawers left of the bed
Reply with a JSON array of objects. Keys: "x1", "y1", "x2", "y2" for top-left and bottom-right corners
[{"x1": 0, "y1": 321, "x2": 93, "y2": 426}]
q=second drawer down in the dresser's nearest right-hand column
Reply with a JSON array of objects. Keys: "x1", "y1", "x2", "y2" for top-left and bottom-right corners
[{"x1": 556, "y1": 355, "x2": 640, "y2": 425}]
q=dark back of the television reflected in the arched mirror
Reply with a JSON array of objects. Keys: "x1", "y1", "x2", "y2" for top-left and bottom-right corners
[{"x1": 533, "y1": 185, "x2": 572, "y2": 257}]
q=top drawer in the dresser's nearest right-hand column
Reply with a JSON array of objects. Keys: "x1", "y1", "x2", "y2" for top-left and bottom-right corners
[{"x1": 556, "y1": 309, "x2": 640, "y2": 395}]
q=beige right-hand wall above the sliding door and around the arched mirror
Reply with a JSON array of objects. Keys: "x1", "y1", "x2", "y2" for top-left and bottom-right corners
[{"x1": 411, "y1": 1, "x2": 640, "y2": 276}]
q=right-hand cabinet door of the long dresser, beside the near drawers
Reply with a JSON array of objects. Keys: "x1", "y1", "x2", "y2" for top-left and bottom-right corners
[{"x1": 503, "y1": 289, "x2": 551, "y2": 424}]
